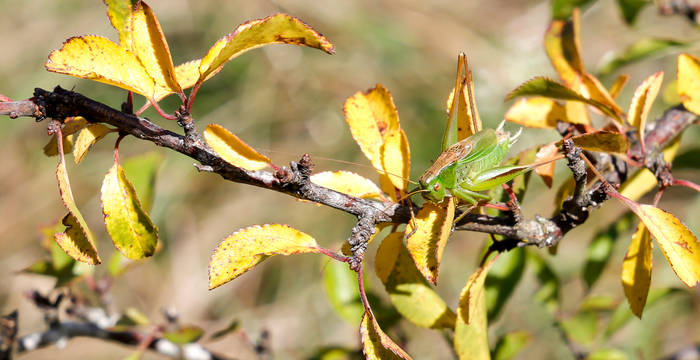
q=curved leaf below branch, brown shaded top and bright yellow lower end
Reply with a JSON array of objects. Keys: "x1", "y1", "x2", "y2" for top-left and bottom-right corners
[{"x1": 374, "y1": 232, "x2": 456, "y2": 329}]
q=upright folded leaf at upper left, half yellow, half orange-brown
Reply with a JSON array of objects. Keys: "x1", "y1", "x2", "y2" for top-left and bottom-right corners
[{"x1": 129, "y1": 1, "x2": 182, "y2": 97}]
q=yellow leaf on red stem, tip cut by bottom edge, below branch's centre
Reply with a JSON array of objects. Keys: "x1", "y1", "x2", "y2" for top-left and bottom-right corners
[{"x1": 360, "y1": 310, "x2": 411, "y2": 360}]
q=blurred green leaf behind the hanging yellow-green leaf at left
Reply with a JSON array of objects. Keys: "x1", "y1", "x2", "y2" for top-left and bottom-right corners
[{"x1": 122, "y1": 151, "x2": 163, "y2": 212}]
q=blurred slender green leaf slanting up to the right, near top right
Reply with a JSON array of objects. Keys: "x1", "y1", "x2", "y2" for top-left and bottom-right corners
[{"x1": 598, "y1": 38, "x2": 686, "y2": 76}]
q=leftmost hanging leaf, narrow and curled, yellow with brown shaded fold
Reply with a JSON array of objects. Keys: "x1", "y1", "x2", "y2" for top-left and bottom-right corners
[{"x1": 54, "y1": 158, "x2": 101, "y2": 265}]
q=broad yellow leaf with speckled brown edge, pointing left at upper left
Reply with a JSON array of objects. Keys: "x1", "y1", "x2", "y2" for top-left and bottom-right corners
[{"x1": 45, "y1": 35, "x2": 155, "y2": 98}]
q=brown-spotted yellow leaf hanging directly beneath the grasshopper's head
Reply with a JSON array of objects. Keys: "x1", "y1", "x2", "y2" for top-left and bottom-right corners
[{"x1": 405, "y1": 197, "x2": 455, "y2": 284}]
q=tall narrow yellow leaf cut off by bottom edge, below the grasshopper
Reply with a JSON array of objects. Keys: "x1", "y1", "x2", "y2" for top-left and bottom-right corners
[{"x1": 454, "y1": 260, "x2": 494, "y2": 360}]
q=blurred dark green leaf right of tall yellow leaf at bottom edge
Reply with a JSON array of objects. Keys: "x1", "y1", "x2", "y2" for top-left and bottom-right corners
[{"x1": 485, "y1": 248, "x2": 526, "y2": 322}]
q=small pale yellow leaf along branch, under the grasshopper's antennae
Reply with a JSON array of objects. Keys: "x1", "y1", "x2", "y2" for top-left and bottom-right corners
[{"x1": 311, "y1": 171, "x2": 386, "y2": 201}]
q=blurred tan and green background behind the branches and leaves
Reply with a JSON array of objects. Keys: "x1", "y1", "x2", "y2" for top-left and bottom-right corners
[{"x1": 0, "y1": 0, "x2": 700, "y2": 359}]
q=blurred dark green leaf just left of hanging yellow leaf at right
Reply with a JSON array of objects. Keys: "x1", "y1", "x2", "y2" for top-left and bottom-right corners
[{"x1": 583, "y1": 212, "x2": 635, "y2": 289}]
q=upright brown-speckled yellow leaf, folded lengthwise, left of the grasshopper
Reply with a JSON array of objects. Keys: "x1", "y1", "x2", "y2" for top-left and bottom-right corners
[{"x1": 343, "y1": 84, "x2": 410, "y2": 200}]
